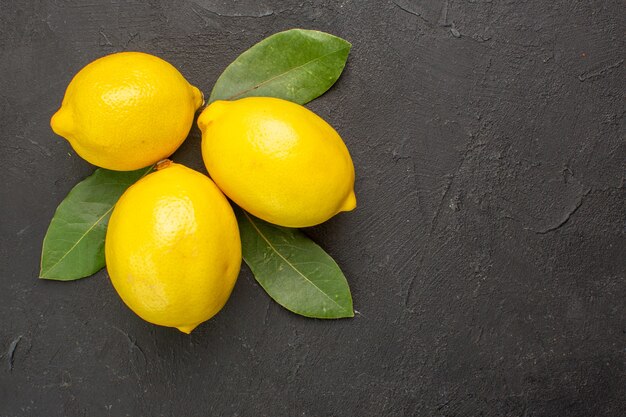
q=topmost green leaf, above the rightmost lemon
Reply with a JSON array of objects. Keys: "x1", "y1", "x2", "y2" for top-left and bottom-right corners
[{"x1": 209, "y1": 29, "x2": 351, "y2": 104}]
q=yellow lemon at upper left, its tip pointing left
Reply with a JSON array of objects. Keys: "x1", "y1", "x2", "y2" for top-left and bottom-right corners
[{"x1": 50, "y1": 52, "x2": 203, "y2": 171}]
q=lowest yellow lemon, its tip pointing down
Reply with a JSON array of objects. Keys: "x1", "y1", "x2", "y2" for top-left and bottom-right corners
[{"x1": 105, "y1": 161, "x2": 241, "y2": 333}]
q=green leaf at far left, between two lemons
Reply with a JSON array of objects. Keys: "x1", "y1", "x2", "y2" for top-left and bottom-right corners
[{"x1": 39, "y1": 167, "x2": 152, "y2": 281}]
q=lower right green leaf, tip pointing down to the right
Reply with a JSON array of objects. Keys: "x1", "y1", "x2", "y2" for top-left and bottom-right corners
[{"x1": 235, "y1": 207, "x2": 354, "y2": 319}]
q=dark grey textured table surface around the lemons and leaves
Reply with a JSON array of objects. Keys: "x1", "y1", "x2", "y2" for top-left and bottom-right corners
[{"x1": 0, "y1": 0, "x2": 626, "y2": 417}]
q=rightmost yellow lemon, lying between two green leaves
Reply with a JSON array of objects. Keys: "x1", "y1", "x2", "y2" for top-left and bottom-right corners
[{"x1": 198, "y1": 97, "x2": 356, "y2": 227}]
